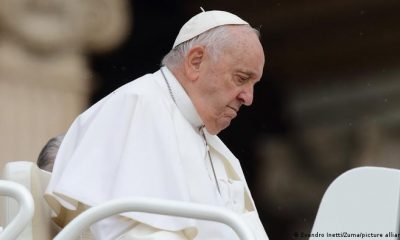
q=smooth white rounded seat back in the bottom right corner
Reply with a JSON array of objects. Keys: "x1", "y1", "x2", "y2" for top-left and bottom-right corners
[{"x1": 310, "y1": 167, "x2": 400, "y2": 240}]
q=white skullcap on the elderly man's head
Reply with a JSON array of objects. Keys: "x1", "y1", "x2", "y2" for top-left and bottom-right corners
[{"x1": 172, "y1": 10, "x2": 249, "y2": 48}]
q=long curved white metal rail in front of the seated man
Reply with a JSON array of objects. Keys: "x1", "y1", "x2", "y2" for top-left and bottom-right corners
[{"x1": 54, "y1": 198, "x2": 255, "y2": 240}]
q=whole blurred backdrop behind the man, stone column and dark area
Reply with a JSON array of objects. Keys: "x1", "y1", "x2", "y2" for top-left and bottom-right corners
[{"x1": 0, "y1": 0, "x2": 400, "y2": 240}]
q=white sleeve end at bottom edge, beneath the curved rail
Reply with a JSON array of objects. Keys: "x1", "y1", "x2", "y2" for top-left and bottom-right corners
[{"x1": 118, "y1": 223, "x2": 190, "y2": 240}]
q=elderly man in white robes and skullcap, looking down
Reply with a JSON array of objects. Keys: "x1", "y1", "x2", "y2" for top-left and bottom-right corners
[{"x1": 47, "y1": 11, "x2": 268, "y2": 240}]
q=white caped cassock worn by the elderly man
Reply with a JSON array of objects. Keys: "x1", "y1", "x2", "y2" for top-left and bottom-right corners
[{"x1": 46, "y1": 67, "x2": 268, "y2": 240}]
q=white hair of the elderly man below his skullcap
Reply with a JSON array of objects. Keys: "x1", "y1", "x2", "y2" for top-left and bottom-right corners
[{"x1": 161, "y1": 25, "x2": 260, "y2": 69}]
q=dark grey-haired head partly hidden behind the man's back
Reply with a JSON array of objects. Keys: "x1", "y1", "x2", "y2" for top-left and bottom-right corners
[{"x1": 37, "y1": 134, "x2": 65, "y2": 172}]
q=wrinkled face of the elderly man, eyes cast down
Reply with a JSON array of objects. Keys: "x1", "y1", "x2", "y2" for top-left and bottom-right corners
[{"x1": 194, "y1": 28, "x2": 264, "y2": 134}]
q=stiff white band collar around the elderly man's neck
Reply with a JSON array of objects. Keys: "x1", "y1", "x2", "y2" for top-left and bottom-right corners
[{"x1": 161, "y1": 66, "x2": 204, "y2": 129}]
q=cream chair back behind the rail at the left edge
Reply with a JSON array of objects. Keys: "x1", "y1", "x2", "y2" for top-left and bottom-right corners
[{"x1": 0, "y1": 161, "x2": 59, "y2": 240}]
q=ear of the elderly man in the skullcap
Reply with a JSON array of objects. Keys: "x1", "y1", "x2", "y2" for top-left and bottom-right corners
[{"x1": 185, "y1": 46, "x2": 205, "y2": 81}]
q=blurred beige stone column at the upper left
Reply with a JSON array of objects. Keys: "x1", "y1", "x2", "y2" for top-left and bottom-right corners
[{"x1": 0, "y1": 0, "x2": 130, "y2": 171}]
